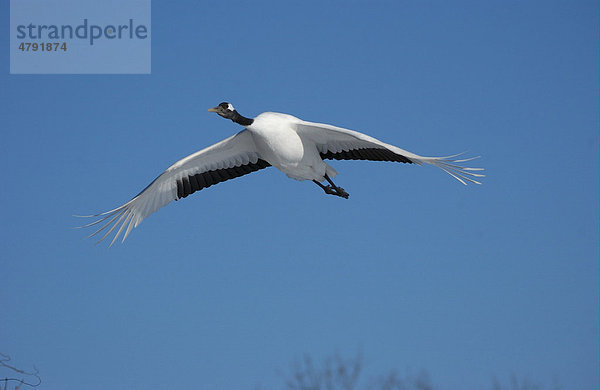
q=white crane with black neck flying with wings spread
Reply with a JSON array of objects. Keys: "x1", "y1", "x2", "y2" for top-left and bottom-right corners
[{"x1": 82, "y1": 102, "x2": 484, "y2": 245}]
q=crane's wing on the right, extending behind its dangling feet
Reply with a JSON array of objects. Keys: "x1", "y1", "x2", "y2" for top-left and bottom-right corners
[{"x1": 296, "y1": 121, "x2": 485, "y2": 185}]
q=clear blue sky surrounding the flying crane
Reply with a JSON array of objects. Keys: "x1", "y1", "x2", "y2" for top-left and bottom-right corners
[{"x1": 0, "y1": 1, "x2": 600, "y2": 390}]
